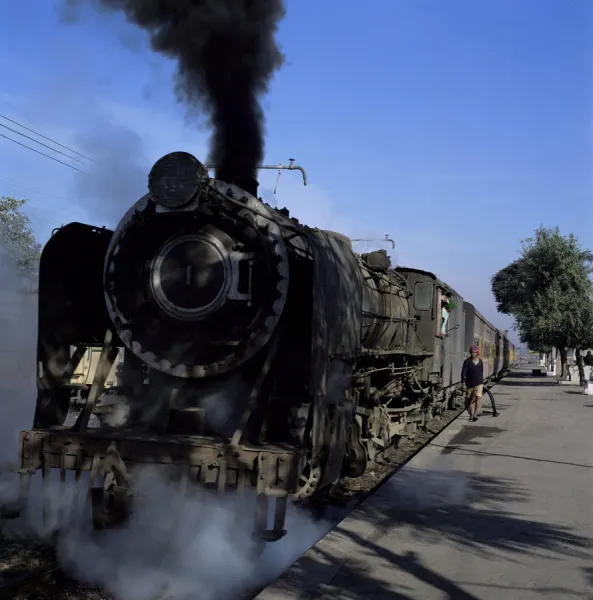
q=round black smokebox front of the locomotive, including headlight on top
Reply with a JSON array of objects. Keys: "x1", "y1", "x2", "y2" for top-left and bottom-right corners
[{"x1": 104, "y1": 152, "x2": 289, "y2": 379}]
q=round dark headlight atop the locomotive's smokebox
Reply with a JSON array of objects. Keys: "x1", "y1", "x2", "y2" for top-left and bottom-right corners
[{"x1": 148, "y1": 152, "x2": 208, "y2": 208}]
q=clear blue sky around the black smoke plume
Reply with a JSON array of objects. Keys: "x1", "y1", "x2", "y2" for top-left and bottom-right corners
[{"x1": 0, "y1": 0, "x2": 593, "y2": 338}]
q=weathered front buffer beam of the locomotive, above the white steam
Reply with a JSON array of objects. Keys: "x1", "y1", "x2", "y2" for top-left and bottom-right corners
[{"x1": 12, "y1": 428, "x2": 306, "y2": 541}]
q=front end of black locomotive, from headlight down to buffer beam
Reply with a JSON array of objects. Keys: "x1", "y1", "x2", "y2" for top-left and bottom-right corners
[{"x1": 3, "y1": 152, "x2": 306, "y2": 541}]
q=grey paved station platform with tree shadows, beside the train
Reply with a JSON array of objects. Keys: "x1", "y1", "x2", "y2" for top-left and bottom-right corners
[{"x1": 257, "y1": 367, "x2": 593, "y2": 600}]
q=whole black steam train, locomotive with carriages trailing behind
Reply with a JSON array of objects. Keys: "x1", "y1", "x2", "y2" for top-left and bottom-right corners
[{"x1": 3, "y1": 152, "x2": 515, "y2": 541}]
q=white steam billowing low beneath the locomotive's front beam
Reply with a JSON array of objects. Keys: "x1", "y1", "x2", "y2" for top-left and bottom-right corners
[{"x1": 12, "y1": 467, "x2": 331, "y2": 600}]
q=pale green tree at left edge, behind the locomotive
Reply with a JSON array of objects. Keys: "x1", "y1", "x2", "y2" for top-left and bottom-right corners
[{"x1": 0, "y1": 197, "x2": 41, "y2": 271}]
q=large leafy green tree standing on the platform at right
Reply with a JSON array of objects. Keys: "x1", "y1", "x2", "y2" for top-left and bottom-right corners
[{"x1": 492, "y1": 227, "x2": 593, "y2": 375}]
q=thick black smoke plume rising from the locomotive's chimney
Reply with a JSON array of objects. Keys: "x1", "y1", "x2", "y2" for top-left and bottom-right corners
[{"x1": 70, "y1": 0, "x2": 285, "y2": 181}]
